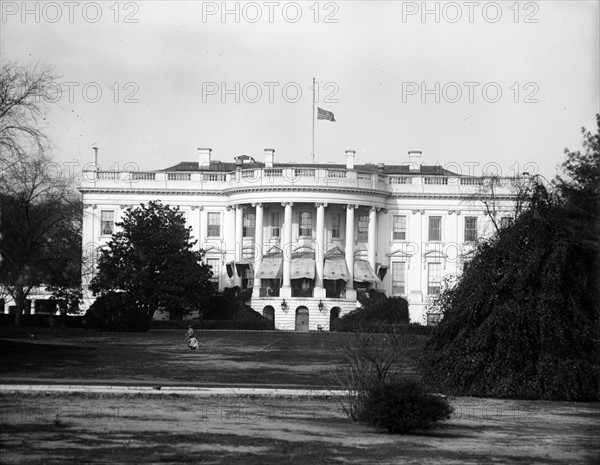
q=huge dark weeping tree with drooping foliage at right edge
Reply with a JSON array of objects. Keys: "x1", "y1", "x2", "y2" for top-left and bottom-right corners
[{"x1": 421, "y1": 115, "x2": 600, "y2": 400}]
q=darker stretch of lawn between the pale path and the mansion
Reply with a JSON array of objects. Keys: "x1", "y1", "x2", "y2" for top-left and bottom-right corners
[{"x1": 0, "y1": 328, "x2": 426, "y2": 388}]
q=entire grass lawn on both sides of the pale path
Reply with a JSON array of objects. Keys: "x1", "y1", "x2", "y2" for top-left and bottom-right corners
[{"x1": 0, "y1": 328, "x2": 600, "y2": 465}]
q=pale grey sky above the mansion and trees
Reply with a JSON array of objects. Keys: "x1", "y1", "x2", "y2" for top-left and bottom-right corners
[{"x1": 0, "y1": 1, "x2": 600, "y2": 179}]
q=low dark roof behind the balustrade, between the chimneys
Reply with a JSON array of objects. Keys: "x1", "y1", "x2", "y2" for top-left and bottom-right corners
[{"x1": 159, "y1": 160, "x2": 458, "y2": 176}]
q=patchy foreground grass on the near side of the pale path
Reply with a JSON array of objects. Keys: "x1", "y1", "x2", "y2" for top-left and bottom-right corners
[{"x1": 0, "y1": 395, "x2": 600, "y2": 465}]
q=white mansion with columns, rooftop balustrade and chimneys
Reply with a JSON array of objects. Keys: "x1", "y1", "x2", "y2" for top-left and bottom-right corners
[{"x1": 80, "y1": 149, "x2": 514, "y2": 330}]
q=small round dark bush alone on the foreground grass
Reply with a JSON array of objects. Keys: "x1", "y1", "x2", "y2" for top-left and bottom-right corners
[{"x1": 363, "y1": 380, "x2": 453, "y2": 434}]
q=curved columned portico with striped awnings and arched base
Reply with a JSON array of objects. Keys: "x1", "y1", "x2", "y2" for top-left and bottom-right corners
[{"x1": 223, "y1": 194, "x2": 382, "y2": 330}]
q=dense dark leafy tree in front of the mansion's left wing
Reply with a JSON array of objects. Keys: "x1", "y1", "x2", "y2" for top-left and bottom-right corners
[{"x1": 90, "y1": 201, "x2": 213, "y2": 320}]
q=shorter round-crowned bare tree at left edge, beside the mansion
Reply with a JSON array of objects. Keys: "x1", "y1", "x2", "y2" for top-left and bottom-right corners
[{"x1": 0, "y1": 155, "x2": 82, "y2": 324}]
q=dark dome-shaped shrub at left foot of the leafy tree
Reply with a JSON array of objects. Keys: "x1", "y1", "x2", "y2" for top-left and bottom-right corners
[{"x1": 85, "y1": 292, "x2": 150, "y2": 332}]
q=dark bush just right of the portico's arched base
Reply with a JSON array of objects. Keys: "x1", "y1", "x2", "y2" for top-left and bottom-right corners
[{"x1": 334, "y1": 297, "x2": 409, "y2": 333}]
